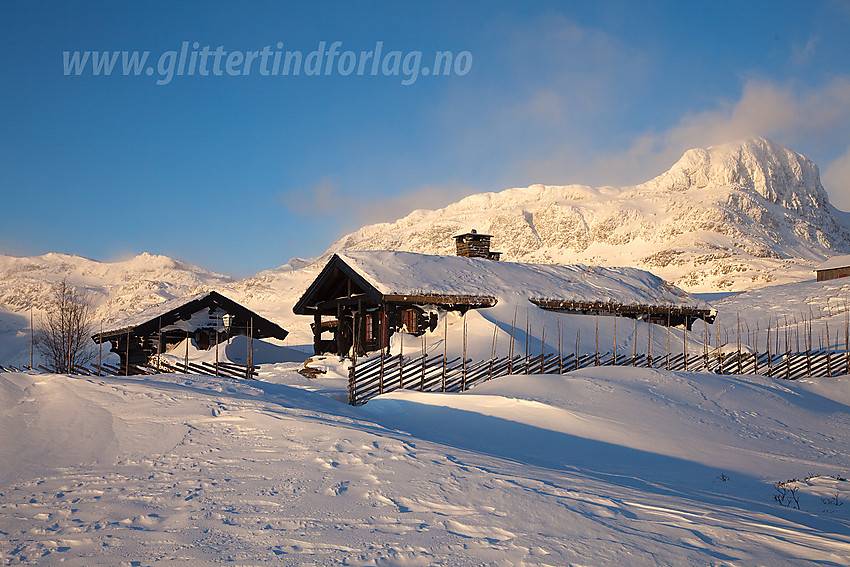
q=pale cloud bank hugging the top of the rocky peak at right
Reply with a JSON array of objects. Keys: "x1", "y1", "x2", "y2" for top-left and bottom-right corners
[{"x1": 522, "y1": 77, "x2": 850, "y2": 202}]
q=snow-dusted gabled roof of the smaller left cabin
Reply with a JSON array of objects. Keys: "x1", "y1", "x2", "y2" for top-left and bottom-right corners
[{"x1": 92, "y1": 291, "x2": 289, "y2": 342}]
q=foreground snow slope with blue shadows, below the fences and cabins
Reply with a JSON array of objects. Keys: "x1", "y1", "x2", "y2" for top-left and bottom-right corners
[{"x1": 0, "y1": 366, "x2": 850, "y2": 566}]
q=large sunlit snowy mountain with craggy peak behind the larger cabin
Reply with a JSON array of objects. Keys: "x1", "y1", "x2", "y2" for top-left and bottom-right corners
[{"x1": 328, "y1": 138, "x2": 850, "y2": 292}]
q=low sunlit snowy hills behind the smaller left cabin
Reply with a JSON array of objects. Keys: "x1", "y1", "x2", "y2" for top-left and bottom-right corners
[{"x1": 0, "y1": 253, "x2": 321, "y2": 366}]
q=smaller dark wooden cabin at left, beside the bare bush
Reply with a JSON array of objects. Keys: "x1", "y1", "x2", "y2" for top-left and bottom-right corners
[{"x1": 92, "y1": 291, "x2": 289, "y2": 369}]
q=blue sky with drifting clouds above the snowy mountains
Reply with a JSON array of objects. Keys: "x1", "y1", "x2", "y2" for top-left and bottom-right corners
[{"x1": 0, "y1": 0, "x2": 850, "y2": 276}]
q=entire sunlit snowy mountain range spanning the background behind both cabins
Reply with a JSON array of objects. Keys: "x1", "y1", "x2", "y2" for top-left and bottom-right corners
[{"x1": 0, "y1": 138, "x2": 850, "y2": 364}]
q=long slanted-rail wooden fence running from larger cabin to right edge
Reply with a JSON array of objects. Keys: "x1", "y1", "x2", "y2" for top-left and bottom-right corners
[{"x1": 348, "y1": 350, "x2": 850, "y2": 405}]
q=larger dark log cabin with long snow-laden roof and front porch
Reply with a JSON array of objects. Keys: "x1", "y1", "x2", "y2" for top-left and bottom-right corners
[{"x1": 293, "y1": 250, "x2": 715, "y2": 354}]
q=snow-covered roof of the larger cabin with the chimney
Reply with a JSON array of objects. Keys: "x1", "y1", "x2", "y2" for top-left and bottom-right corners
[{"x1": 294, "y1": 250, "x2": 711, "y2": 313}]
